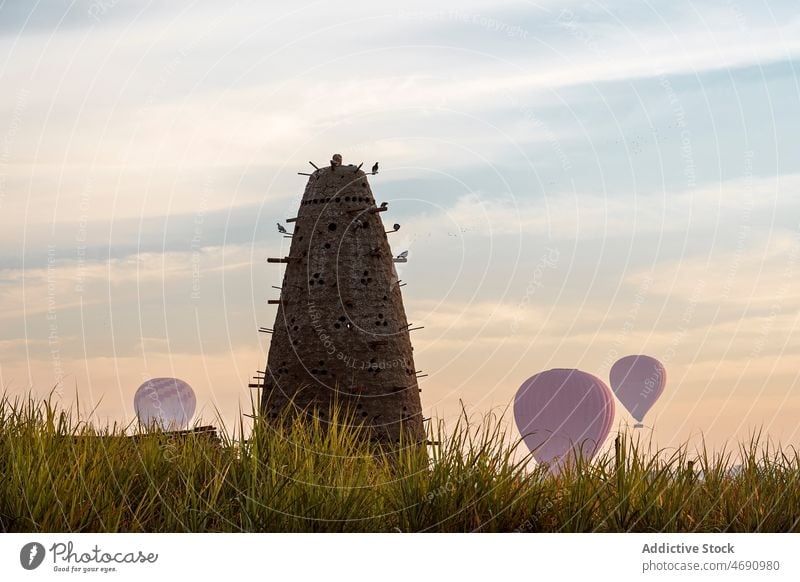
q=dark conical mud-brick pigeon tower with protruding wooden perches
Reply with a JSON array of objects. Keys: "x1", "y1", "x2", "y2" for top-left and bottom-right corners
[{"x1": 261, "y1": 156, "x2": 425, "y2": 442}]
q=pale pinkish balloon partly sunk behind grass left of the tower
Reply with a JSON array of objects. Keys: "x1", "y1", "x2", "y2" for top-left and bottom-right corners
[{"x1": 133, "y1": 378, "x2": 197, "y2": 430}]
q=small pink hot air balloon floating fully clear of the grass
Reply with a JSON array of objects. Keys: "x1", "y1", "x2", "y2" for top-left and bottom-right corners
[{"x1": 609, "y1": 356, "x2": 667, "y2": 428}]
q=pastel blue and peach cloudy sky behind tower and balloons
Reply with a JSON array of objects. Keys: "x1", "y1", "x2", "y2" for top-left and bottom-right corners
[{"x1": 0, "y1": 0, "x2": 800, "y2": 448}]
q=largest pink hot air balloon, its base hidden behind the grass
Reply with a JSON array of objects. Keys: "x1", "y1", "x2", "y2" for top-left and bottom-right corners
[{"x1": 514, "y1": 369, "x2": 614, "y2": 470}]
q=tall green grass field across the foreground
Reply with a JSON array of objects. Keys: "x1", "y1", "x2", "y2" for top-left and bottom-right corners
[{"x1": 0, "y1": 397, "x2": 800, "y2": 532}]
